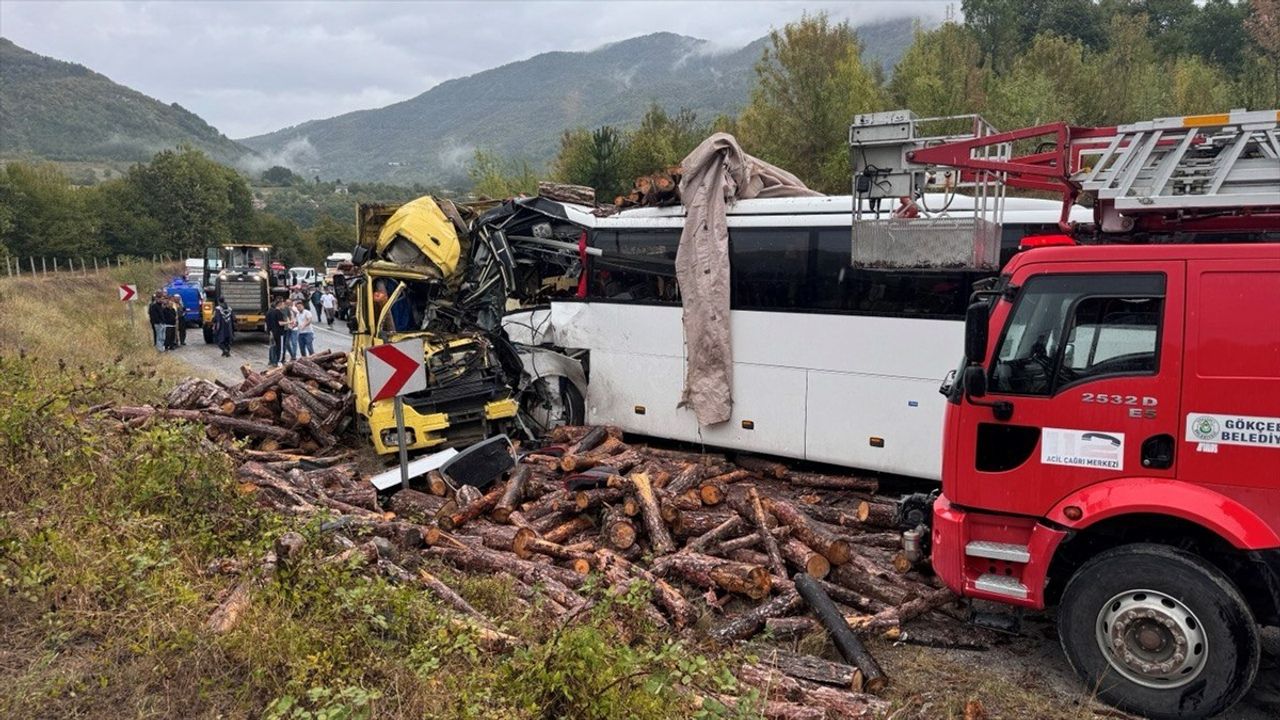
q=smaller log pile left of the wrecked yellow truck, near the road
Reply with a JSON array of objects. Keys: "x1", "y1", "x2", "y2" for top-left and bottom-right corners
[{"x1": 110, "y1": 351, "x2": 353, "y2": 459}]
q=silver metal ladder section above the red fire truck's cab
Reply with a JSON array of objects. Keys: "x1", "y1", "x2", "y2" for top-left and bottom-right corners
[{"x1": 1071, "y1": 110, "x2": 1280, "y2": 232}]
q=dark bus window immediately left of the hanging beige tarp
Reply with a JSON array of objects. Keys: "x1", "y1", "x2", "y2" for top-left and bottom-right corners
[{"x1": 590, "y1": 229, "x2": 680, "y2": 304}]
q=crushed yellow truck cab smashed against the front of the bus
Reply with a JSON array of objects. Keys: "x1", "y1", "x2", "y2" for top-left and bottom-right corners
[{"x1": 347, "y1": 197, "x2": 520, "y2": 454}]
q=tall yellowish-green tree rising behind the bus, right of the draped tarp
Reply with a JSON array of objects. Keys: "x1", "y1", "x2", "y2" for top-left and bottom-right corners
[{"x1": 739, "y1": 14, "x2": 884, "y2": 192}]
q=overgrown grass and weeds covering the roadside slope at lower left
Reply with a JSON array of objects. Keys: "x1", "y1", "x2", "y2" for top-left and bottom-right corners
[{"x1": 0, "y1": 266, "x2": 750, "y2": 719}]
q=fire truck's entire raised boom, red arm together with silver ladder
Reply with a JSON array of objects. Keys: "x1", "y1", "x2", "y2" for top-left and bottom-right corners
[{"x1": 850, "y1": 110, "x2": 1280, "y2": 233}]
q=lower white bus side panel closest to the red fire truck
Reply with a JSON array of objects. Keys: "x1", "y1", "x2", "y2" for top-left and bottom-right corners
[{"x1": 805, "y1": 370, "x2": 946, "y2": 479}]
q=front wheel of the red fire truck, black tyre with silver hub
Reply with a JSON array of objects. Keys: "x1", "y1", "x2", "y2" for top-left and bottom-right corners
[{"x1": 1057, "y1": 543, "x2": 1261, "y2": 719}]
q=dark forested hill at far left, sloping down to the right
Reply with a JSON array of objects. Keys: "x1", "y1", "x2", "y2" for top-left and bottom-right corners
[{"x1": 0, "y1": 37, "x2": 251, "y2": 163}]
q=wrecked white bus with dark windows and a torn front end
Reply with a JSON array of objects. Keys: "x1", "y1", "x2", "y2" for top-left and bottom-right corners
[{"x1": 503, "y1": 196, "x2": 1089, "y2": 479}]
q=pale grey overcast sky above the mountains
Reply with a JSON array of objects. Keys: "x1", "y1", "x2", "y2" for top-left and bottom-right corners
[{"x1": 0, "y1": 0, "x2": 942, "y2": 137}]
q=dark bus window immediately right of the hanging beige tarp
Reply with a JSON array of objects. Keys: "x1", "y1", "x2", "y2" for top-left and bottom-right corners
[{"x1": 728, "y1": 228, "x2": 809, "y2": 310}]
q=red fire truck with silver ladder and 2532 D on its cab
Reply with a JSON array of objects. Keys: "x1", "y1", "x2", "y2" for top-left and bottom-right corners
[{"x1": 851, "y1": 110, "x2": 1280, "y2": 717}]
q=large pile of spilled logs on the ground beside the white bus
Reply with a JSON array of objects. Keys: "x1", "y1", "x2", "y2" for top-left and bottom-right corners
[{"x1": 325, "y1": 427, "x2": 973, "y2": 717}]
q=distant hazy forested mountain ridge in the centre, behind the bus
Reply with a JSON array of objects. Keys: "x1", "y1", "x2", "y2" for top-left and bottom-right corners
[{"x1": 242, "y1": 19, "x2": 911, "y2": 184}]
